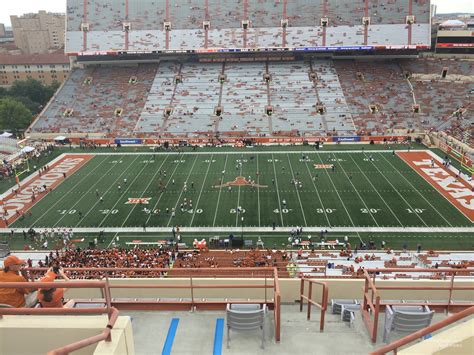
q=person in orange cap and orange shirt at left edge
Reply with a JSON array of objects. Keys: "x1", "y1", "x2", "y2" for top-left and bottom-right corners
[{"x1": 0, "y1": 255, "x2": 31, "y2": 308}]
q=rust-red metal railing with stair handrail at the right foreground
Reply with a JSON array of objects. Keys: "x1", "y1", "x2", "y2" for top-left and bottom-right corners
[{"x1": 362, "y1": 268, "x2": 474, "y2": 343}]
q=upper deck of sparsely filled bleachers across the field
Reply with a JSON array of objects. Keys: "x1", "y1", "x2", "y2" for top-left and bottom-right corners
[{"x1": 66, "y1": 0, "x2": 430, "y2": 53}]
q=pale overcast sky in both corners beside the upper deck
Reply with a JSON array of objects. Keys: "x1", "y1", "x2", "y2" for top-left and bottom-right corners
[{"x1": 0, "y1": 0, "x2": 474, "y2": 26}]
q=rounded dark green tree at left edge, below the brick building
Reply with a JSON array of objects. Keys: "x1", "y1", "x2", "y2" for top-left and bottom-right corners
[{"x1": 0, "y1": 97, "x2": 33, "y2": 136}]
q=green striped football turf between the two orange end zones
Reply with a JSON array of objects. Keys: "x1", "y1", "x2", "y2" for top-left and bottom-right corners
[{"x1": 11, "y1": 150, "x2": 474, "y2": 232}]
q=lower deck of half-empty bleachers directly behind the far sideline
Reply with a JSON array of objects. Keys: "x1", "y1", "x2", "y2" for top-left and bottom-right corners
[{"x1": 30, "y1": 59, "x2": 474, "y2": 140}]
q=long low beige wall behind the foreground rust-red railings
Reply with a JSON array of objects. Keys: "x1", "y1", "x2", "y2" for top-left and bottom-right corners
[{"x1": 61, "y1": 278, "x2": 474, "y2": 303}]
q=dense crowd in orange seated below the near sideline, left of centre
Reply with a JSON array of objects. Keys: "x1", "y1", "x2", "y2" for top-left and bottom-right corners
[{"x1": 27, "y1": 247, "x2": 288, "y2": 279}]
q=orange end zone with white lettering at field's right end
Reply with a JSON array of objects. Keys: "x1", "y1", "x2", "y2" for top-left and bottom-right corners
[{"x1": 397, "y1": 152, "x2": 474, "y2": 222}]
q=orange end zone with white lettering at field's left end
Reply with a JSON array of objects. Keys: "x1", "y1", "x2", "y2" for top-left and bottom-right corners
[{"x1": 0, "y1": 154, "x2": 94, "y2": 228}]
